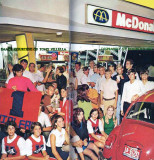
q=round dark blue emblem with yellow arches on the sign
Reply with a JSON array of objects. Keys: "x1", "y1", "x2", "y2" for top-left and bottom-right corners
[{"x1": 93, "y1": 9, "x2": 109, "y2": 23}]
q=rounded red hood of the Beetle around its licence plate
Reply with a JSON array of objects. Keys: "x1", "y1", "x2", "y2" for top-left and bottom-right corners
[{"x1": 117, "y1": 119, "x2": 154, "y2": 160}]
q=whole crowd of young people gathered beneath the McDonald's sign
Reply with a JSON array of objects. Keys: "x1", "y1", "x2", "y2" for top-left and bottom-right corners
[{"x1": 0, "y1": 59, "x2": 154, "y2": 160}]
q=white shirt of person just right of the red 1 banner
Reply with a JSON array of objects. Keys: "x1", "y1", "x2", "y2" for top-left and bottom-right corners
[{"x1": 38, "y1": 112, "x2": 51, "y2": 127}]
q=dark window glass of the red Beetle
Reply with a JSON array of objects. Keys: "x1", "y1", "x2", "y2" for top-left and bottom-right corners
[{"x1": 127, "y1": 102, "x2": 154, "y2": 123}]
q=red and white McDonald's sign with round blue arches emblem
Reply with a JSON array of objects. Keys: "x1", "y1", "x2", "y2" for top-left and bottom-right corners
[{"x1": 86, "y1": 5, "x2": 154, "y2": 33}]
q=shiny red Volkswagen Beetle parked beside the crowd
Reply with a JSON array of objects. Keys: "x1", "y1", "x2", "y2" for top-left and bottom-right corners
[{"x1": 103, "y1": 90, "x2": 154, "y2": 160}]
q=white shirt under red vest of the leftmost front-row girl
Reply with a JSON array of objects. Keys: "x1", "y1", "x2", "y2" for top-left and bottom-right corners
[{"x1": 2, "y1": 134, "x2": 26, "y2": 156}]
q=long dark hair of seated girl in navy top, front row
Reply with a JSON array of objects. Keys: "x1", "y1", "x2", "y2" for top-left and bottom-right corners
[{"x1": 73, "y1": 108, "x2": 85, "y2": 127}]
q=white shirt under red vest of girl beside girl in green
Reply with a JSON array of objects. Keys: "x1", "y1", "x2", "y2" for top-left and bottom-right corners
[{"x1": 87, "y1": 118, "x2": 104, "y2": 134}]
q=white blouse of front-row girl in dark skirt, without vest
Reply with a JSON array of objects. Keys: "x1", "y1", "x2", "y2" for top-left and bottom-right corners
[{"x1": 47, "y1": 128, "x2": 65, "y2": 147}]
